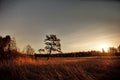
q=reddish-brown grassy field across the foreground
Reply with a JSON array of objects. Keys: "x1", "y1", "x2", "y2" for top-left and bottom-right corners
[{"x1": 0, "y1": 56, "x2": 120, "y2": 80}]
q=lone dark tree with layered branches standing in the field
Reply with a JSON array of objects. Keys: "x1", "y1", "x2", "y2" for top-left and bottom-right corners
[{"x1": 44, "y1": 34, "x2": 62, "y2": 59}]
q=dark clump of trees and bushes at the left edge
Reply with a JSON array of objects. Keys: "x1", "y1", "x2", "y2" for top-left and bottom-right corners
[{"x1": 0, "y1": 35, "x2": 22, "y2": 61}]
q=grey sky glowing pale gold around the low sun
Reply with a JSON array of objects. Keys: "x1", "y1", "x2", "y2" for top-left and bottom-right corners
[{"x1": 0, "y1": 0, "x2": 120, "y2": 52}]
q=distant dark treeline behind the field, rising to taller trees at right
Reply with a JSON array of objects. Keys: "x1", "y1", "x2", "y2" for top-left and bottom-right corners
[{"x1": 34, "y1": 46, "x2": 120, "y2": 57}]
